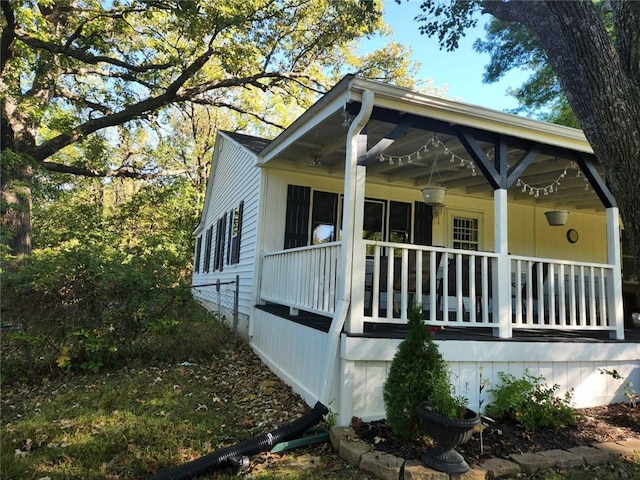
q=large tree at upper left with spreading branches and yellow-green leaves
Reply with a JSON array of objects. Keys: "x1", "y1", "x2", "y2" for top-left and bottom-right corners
[{"x1": 0, "y1": 0, "x2": 416, "y2": 255}]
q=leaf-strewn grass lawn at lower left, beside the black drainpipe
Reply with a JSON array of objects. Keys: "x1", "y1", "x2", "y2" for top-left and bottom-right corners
[{"x1": 0, "y1": 343, "x2": 318, "y2": 478}]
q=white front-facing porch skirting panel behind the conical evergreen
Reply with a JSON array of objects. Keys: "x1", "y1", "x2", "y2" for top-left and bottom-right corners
[{"x1": 339, "y1": 336, "x2": 640, "y2": 424}]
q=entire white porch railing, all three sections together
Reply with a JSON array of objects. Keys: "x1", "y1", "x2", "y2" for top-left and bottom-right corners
[{"x1": 260, "y1": 240, "x2": 621, "y2": 331}]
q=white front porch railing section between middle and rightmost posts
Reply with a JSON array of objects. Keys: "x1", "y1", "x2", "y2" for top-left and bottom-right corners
[{"x1": 511, "y1": 256, "x2": 615, "y2": 330}]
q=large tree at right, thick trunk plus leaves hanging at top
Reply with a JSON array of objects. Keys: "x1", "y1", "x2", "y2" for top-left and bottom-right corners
[{"x1": 410, "y1": 0, "x2": 640, "y2": 278}]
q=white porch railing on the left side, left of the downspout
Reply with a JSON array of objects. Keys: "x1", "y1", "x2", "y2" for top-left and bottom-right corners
[{"x1": 260, "y1": 242, "x2": 341, "y2": 317}]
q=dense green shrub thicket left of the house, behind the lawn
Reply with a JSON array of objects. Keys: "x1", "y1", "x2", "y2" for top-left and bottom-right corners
[{"x1": 1, "y1": 242, "x2": 224, "y2": 382}]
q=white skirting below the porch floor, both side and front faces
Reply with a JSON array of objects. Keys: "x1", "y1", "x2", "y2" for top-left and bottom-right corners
[{"x1": 251, "y1": 308, "x2": 640, "y2": 425}]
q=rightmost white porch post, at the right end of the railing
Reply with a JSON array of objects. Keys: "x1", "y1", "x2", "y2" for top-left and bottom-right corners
[{"x1": 607, "y1": 207, "x2": 624, "y2": 340}]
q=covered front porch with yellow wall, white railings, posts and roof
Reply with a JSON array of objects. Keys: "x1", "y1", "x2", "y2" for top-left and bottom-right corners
[{"x1": 256, "y1": 77, "x2": 624, "y2": 340}]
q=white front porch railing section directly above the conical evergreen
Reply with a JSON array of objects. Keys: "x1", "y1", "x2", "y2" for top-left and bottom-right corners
[{"x1": 364, "y1": 241, "x2": 497, "y2": 327}]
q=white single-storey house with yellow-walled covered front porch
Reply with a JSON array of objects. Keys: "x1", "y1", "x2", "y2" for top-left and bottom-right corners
[{"x1": 193, "y1": 76, "x2": 640, "y2": 424}]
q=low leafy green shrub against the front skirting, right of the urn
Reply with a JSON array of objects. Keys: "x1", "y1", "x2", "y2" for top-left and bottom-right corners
[{"x1": 486, "y1": 372, "x2": 577, "y2": 431}]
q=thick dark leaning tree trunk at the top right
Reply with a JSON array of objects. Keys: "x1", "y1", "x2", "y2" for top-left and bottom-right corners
[{"x1": 483, "y1": 1, "x2": 640, "y2": 282}]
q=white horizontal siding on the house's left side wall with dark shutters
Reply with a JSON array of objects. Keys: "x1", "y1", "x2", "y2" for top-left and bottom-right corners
[{"x1": 192, "y1": 136, "x2": 260, "y2": 336}]
